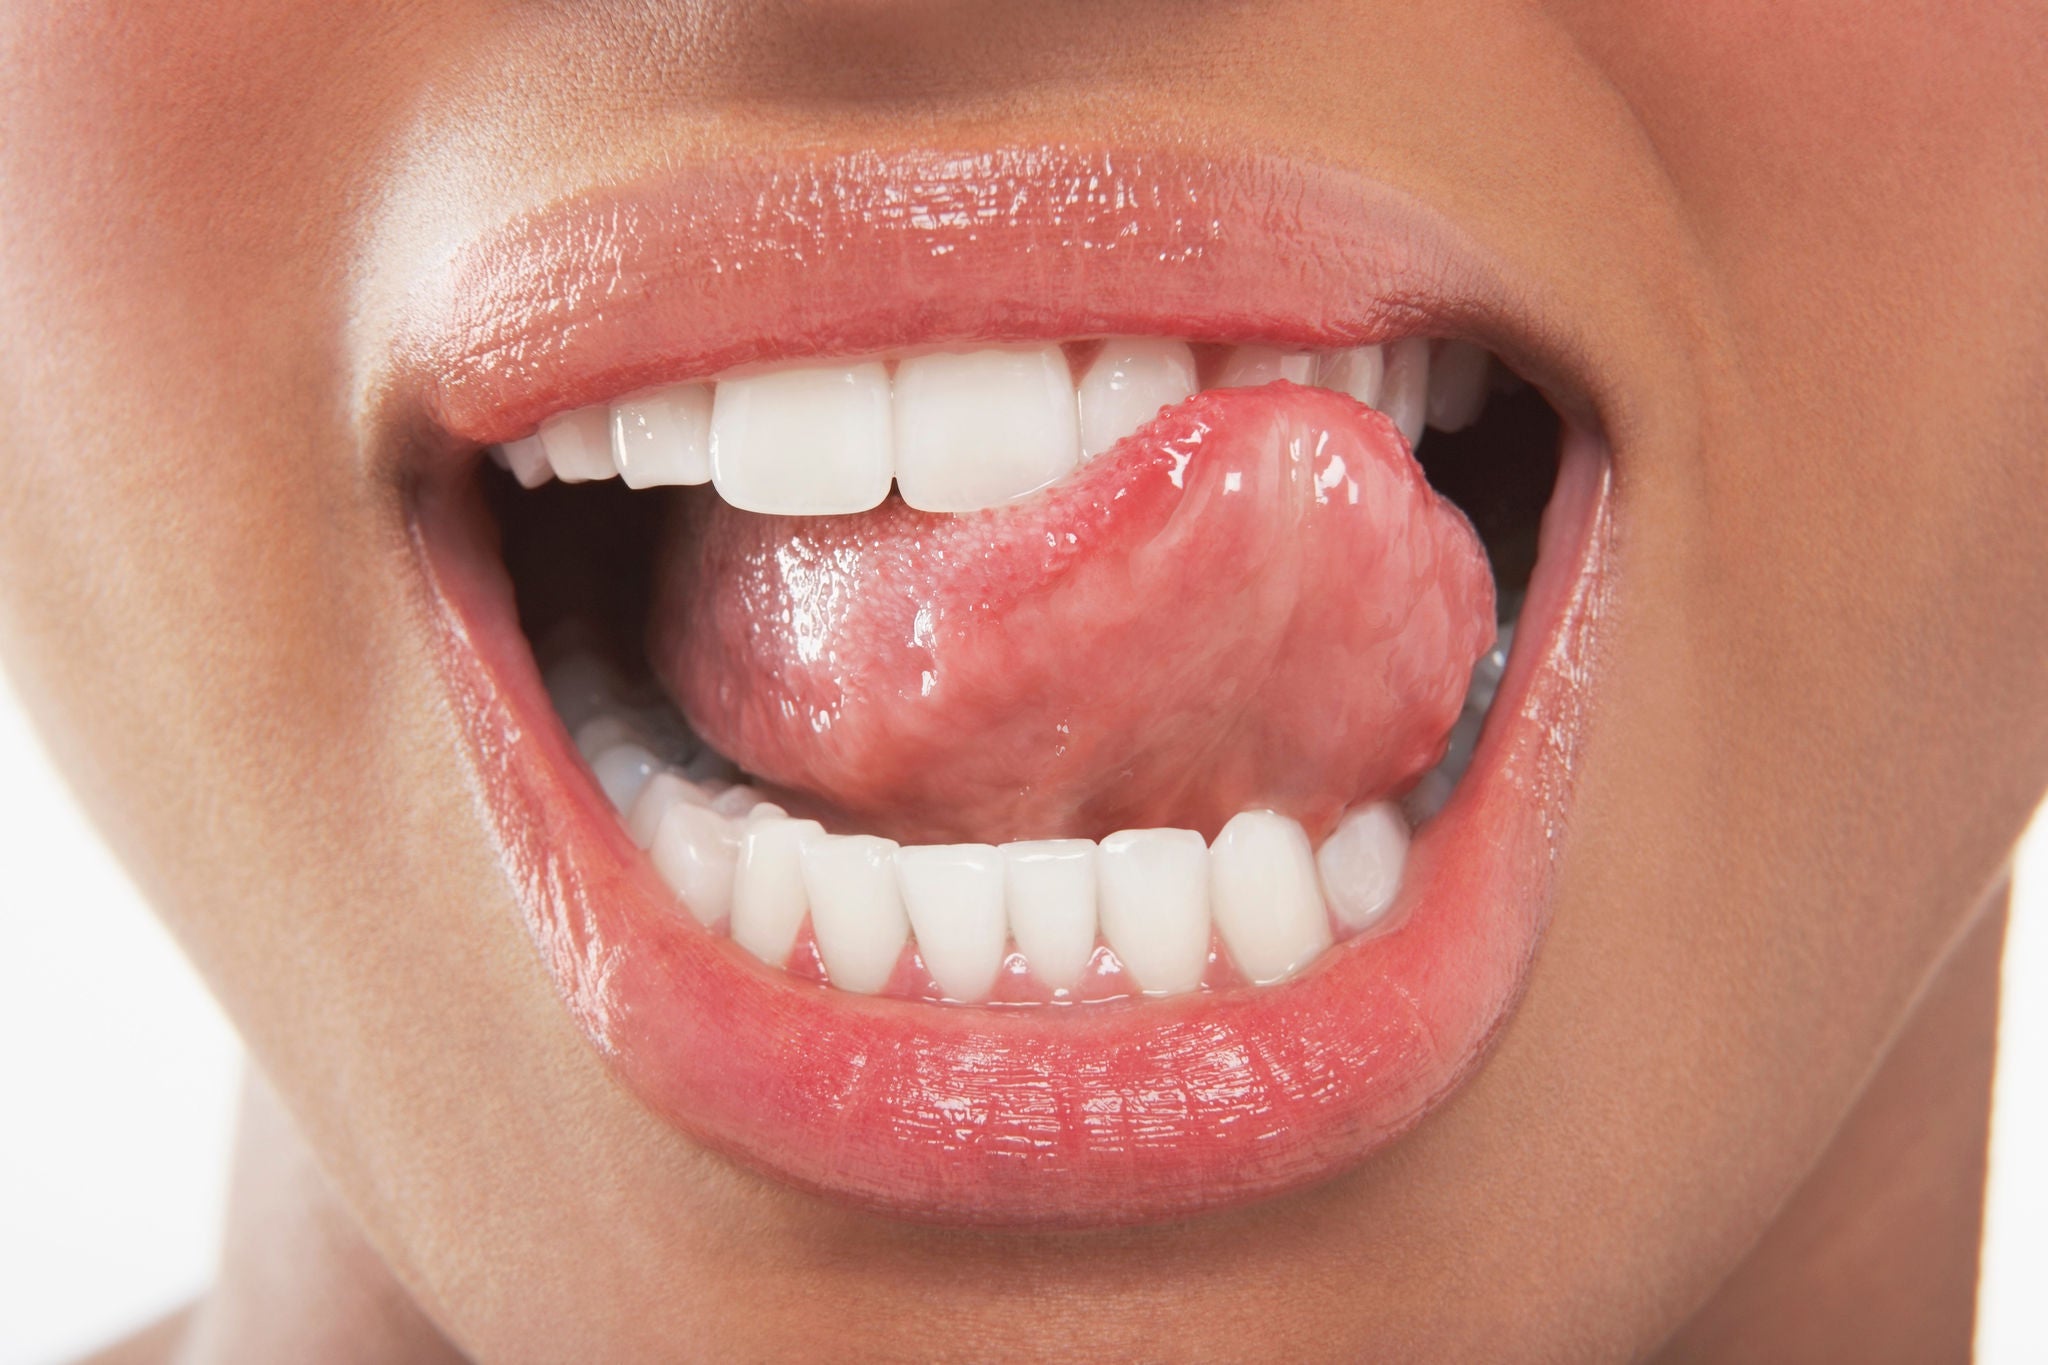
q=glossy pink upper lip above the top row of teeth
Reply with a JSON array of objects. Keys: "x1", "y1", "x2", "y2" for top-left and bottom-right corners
[{"x1": 381, "y1": 147, "x2": 1599, "y2": 450}]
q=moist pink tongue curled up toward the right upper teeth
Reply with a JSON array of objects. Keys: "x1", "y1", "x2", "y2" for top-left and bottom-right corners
[{"x1": 649, "y1": 383, "x2": 1493, "y2": 843}]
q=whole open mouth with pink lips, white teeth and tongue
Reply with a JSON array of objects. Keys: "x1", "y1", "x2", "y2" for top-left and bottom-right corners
[{"x1": 393, "y1": 149, "x2": 1612, "y2": 1228}]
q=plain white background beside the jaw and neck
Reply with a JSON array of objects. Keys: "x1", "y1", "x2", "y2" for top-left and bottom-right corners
[{"x1": 0, "y1": 679, "x2": 2048, "y2": 1365}]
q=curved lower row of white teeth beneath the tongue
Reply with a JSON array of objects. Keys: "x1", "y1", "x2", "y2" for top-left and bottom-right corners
[{"x1": 547, "y1": 605, "x2": 1513, "y2": 1003}]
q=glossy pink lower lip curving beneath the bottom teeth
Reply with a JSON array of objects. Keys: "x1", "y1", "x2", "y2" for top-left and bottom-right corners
[{"x1": 416, "y1": 434, "x2": 1610, "y2": 1228}]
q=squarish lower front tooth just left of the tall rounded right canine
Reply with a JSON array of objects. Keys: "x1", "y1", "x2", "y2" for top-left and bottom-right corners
[{"x1": 1096, "y1": 829, "x2": 1208, "y2": 995}]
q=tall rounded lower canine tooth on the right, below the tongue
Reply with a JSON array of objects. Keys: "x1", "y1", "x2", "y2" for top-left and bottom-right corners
[{"x1": 1208, "y1": 810, "x2": 1329, "y2": 986}]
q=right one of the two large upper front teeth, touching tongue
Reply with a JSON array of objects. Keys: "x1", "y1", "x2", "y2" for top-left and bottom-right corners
[{"x1": 895, "y1": 346, "x2": 1081, "y2": 512}]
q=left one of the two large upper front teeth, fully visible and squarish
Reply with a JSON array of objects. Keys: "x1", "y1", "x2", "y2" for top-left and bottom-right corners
[{"x1": 711, "y1": 360, "x2": 895, "y2": 516}]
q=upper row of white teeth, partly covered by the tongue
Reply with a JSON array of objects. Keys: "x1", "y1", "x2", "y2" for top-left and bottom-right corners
[{"x1": 498, "y1": 338, "x2": 1489, "y2": 516}]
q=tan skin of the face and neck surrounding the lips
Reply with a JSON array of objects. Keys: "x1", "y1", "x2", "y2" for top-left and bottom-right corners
[{"x1": 0, "y1": 0, "x2": 2048, "y2": 1361}]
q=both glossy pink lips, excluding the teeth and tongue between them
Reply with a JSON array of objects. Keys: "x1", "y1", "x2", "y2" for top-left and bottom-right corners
[{"x1": 401, "y1": 151, "x2": 1610, "y2": 1226}]
